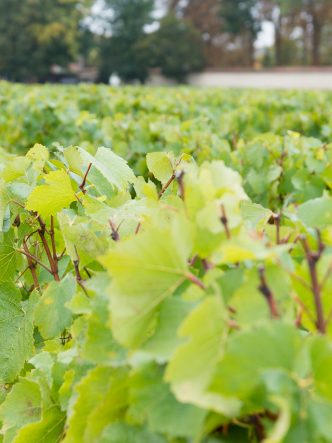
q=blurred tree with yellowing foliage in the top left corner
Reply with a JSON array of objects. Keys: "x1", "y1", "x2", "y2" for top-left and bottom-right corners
[{"x1": 0, "y1": 0, "x2": 88, "y2": 81}]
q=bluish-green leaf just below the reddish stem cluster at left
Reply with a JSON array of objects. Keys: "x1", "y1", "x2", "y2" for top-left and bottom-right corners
[{"x1": 35, "y1": 274, "x2": 76, "y2": 338}]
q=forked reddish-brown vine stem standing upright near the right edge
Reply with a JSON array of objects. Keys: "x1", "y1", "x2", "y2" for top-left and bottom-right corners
[{"x1": 301, "y1": 231, "x2": 326, "y2": 334}]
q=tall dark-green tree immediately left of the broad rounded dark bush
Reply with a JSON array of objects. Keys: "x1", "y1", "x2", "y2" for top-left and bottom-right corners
[{"x1": 99, "y1": 0, "x2": 154, "y2": 82}]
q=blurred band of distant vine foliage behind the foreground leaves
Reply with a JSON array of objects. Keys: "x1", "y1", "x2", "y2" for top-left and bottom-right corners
[{"x1": 0, "y1": 82, "x2": 332, "y2": 157}]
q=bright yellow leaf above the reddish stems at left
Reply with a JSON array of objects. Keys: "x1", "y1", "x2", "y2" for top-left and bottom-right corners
[{"x1": 26, "y1": 169, "x2": 75, "y2": 218}]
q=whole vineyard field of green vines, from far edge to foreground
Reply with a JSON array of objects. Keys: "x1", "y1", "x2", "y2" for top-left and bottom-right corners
[{"x1": 0, "y1": 83, "x2": 332, "y2": 443}]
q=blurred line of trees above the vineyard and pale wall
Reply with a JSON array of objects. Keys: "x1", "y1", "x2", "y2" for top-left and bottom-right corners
[{"x1": 0, "y1": 0, "x2": 332, "y2": 86}]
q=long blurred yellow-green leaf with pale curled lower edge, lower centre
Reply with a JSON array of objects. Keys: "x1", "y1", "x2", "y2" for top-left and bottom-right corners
[{"x1": 165, "y1": 297, "x2": 240, "y2": 416}]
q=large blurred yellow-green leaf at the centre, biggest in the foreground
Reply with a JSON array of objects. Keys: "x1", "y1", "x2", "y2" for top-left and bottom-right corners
[{"x1": 102, "y1": 219, "x2": 191, "y2": 347}]
